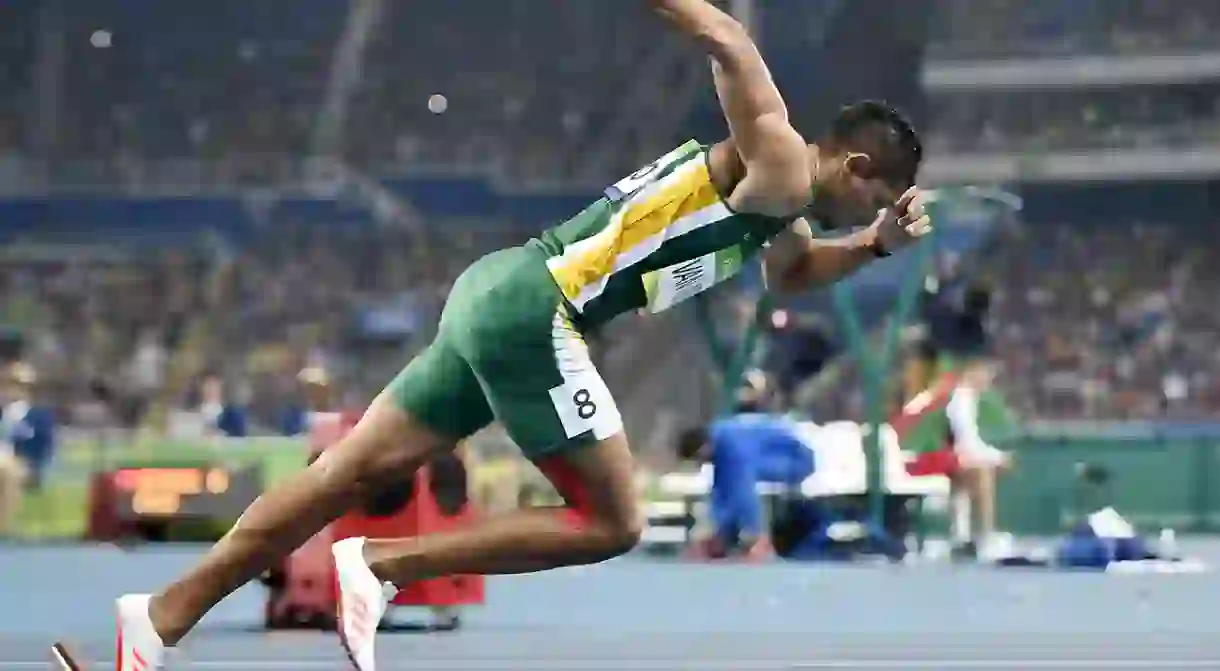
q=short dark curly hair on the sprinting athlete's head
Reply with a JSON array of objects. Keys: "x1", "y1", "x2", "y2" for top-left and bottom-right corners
[{"x1": 830, "y1": 100, "x2": 924, "y2": 184}]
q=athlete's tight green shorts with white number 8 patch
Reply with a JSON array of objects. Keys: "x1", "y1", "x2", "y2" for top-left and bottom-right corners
[{"x1": 388, "y1": 246, "x2": 622, "y2": 459}]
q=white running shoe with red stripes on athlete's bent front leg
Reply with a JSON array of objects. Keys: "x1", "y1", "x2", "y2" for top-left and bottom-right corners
[{"x1": 331, "y1": 538, "x2": 398, "y2": 671}]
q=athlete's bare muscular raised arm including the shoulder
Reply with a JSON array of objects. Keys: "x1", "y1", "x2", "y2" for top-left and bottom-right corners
[{"x1": 649, "y1": 0, "x2": 813, "y2": 216}]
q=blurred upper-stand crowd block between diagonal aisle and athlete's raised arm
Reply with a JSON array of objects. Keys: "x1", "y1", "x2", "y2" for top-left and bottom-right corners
[{"x1": 350, "y1": 0, "x2": 667, "y2": 178}]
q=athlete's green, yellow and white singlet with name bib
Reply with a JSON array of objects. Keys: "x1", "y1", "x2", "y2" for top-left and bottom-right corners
[{"x1": 532, "y1": 140, "x2": 788, "y2": 327}]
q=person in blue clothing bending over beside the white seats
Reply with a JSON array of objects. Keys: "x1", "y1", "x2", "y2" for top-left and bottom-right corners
[{"x1": 678, "y1": 412, "x2": 814, "y2": 558}]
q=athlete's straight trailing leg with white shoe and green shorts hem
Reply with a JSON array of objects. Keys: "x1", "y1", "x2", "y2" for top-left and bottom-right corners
[{"x1": 89, "y1": 329, "x2": 492, "y2": 671}]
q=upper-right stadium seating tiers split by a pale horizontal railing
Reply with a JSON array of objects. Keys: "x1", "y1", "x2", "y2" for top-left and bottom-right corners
[{"x1": 927, "y1": 0, "x2": 1220, "y2": 154}]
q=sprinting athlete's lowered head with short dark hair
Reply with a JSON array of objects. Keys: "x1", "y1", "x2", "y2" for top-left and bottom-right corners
[{"x1": 809, "y1": 100, "x2": 924, "y2": 228}]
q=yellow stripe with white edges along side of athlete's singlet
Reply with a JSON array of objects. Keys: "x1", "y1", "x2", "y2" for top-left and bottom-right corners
[{"x1": 548, "y1": 160, "x2": 732, "y2": 310}]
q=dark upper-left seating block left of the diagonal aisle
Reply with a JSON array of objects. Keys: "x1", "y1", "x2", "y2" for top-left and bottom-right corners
[{"x1": 59, "y1": 0, "x2": 346, "y2": 159}]
